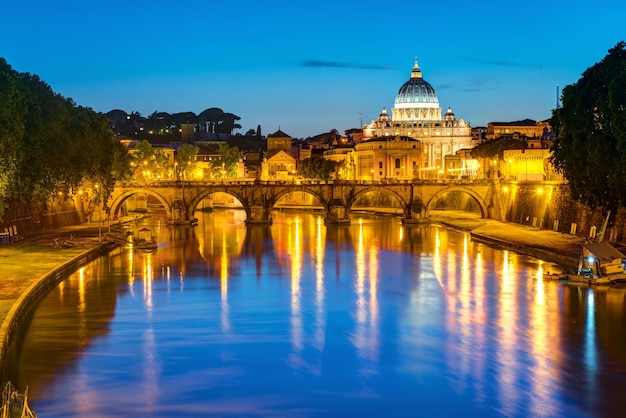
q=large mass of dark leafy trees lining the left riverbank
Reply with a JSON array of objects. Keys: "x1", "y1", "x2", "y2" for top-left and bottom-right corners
[{"x1": 0, "y1": 59, "x2": 128, "y2": 213}]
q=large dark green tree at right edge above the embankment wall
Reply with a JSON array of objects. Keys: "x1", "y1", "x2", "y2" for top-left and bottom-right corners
[{"x1": 550, "y1": 41, "x2": 626, "y2": 211}]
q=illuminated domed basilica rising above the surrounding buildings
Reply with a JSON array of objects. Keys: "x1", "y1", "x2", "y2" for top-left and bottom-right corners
[{"x1": 363, "y1": 60, "x2": 474, "y2": 173}]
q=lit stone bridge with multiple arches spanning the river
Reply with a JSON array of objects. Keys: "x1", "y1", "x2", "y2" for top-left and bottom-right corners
[{"x1": 107, "y1": 179, "x2": 503, "y2": 225}]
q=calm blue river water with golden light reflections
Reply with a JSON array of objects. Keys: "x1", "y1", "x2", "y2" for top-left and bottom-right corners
[{"x1": 7, "y1": 210, "x2": 626, "y2": 418}]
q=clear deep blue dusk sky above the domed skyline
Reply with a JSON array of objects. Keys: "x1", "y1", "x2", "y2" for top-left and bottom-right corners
[{"x1": 0, "y1": 0, "x2": 626, "y2": 138}]
